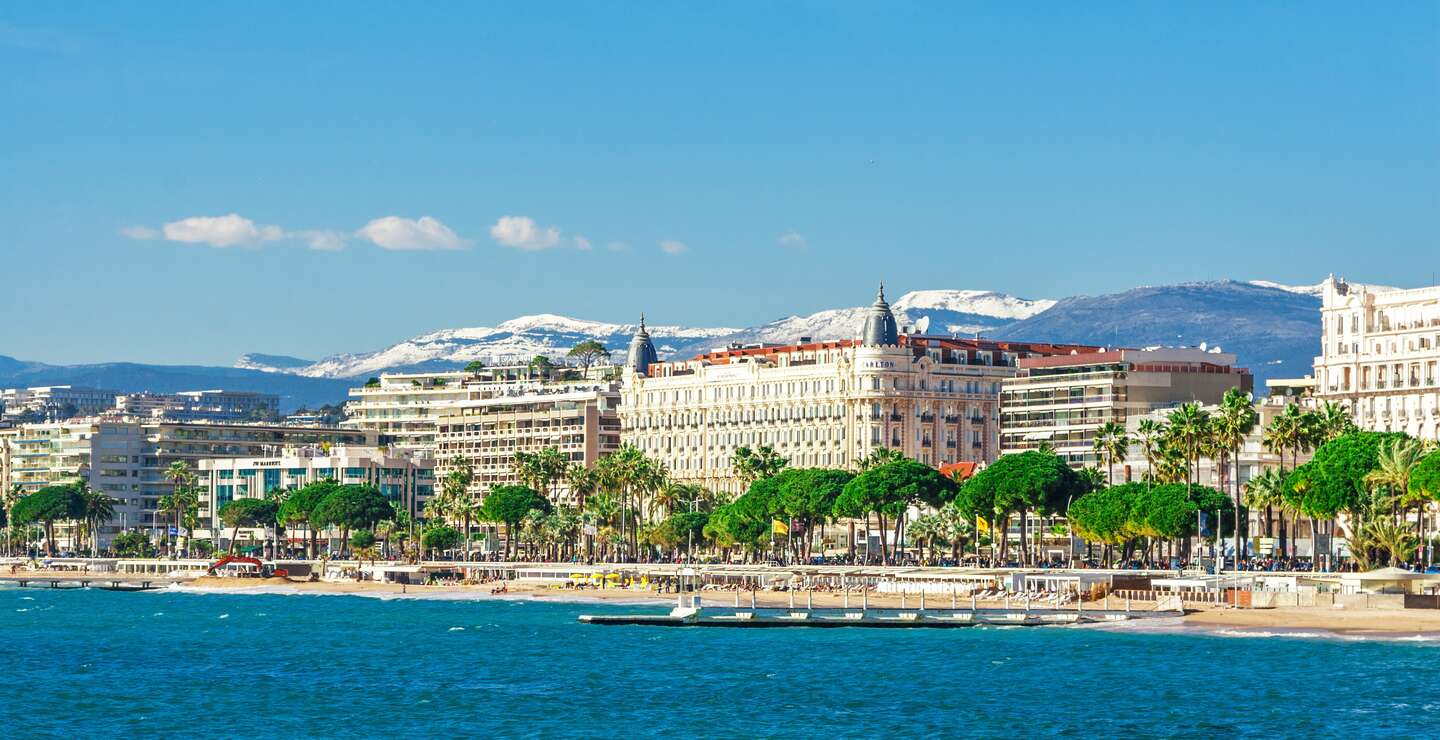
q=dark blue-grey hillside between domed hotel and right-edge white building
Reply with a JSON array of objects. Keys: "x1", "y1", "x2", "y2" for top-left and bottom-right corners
[{"x1": 991, "y1": 281, "x2": 1320, "y2": 382}]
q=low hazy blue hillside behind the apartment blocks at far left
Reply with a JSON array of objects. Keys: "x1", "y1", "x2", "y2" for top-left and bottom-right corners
[{"x1": 0, "y1": 356, "x2": 351, "y2": 412}]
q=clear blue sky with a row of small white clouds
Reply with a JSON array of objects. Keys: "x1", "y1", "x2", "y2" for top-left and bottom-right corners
[{"x1": 0, "y1": 1, "x2": 1440, "y2": 364}]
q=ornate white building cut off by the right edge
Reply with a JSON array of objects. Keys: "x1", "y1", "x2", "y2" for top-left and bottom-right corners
[{"x1": 1315, "y1": 276, "x2": 1440, "y2": 439}]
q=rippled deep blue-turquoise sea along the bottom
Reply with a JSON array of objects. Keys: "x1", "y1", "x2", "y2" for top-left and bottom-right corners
[{"x1": 0, "y1": 589, "x2": 1440, "y2": 737}]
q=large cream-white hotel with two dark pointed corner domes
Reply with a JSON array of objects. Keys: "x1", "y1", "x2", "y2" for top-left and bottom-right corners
[{"x1": 619, "y1": 291, "x2": 1094, "y2": 494}]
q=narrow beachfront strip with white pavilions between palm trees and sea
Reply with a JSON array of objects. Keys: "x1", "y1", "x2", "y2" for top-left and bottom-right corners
[{"x1": 0, "y1": 559, "x2": 1416, "y2": 606}]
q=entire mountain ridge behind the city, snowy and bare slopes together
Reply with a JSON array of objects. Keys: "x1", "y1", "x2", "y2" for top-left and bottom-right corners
[{"x1": 0, "y1": 281, "x2": 1347, "y2": 407}]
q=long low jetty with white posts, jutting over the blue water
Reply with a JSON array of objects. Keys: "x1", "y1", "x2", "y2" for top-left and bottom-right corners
[{"x1": 580, "y1": 569, "x2": 1185, "y2": 628}]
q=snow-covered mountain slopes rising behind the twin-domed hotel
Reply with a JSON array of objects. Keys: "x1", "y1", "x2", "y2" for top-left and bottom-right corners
[{"x1": 236, "y1": 291, "x2": 1054, "y2": 377}]
